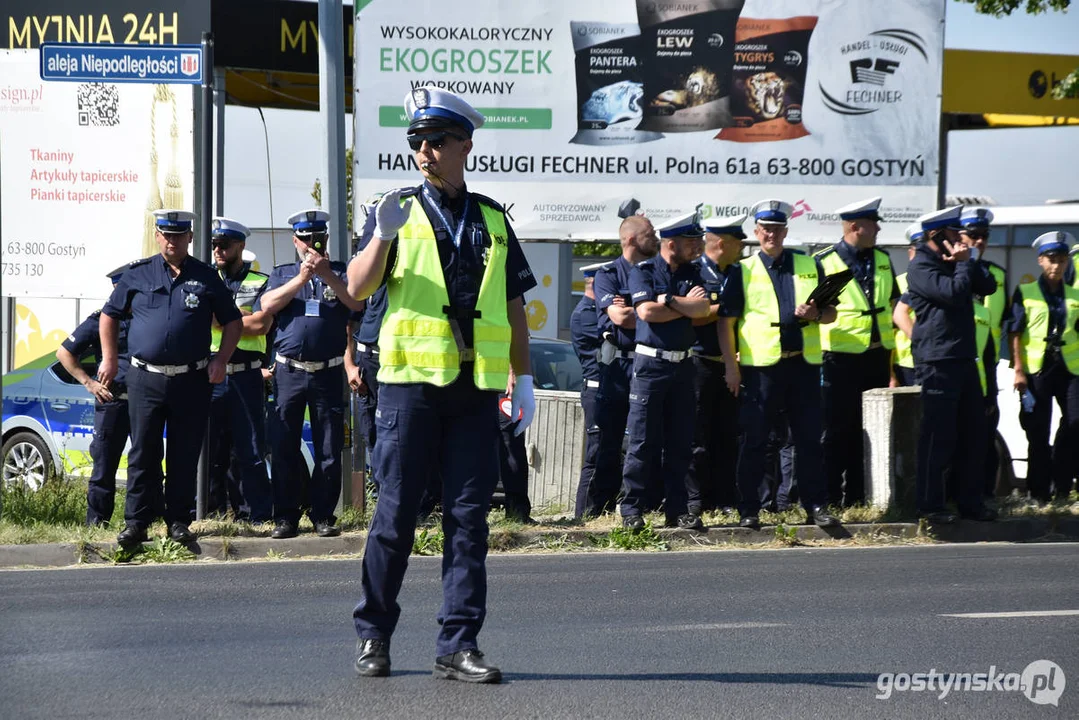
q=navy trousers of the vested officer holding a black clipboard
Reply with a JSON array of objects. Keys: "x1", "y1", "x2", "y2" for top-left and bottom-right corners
[{"x1": 738, "y1": 356, "x2": 828, "y2": 517}]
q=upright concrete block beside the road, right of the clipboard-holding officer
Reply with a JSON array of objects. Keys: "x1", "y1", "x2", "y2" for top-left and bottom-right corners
[{"x1": 862, "y1": 388, "x2": 921, "y2": 512}]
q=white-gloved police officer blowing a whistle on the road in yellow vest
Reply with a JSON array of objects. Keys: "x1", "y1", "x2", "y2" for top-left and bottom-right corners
[{"x1": 349, "y1": 86, "x2": 535, "y2": 682}]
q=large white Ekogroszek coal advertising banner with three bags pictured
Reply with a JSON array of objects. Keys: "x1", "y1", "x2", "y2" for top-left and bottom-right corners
[{"x1": 354, "y1": 0, "x2": 944, "y2": 242}]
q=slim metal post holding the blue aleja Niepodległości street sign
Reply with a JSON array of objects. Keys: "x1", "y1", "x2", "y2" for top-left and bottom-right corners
[{"x1": 195, "y1": 32, "x2": 214, "y2": 520}]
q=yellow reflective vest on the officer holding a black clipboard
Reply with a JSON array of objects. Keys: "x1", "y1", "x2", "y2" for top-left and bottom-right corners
[{"x1": 738, "y1": 250, "x2": 821, "y2": 367}]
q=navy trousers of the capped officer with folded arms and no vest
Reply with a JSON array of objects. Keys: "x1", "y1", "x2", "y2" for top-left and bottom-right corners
[{"x1": 620, "y1": 355, "x2": 694, "y2": 522}]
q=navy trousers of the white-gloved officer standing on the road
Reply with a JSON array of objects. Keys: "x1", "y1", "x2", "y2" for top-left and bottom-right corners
[{"x1": 353, "y1": 371, "x2": 498, "y2": 655}]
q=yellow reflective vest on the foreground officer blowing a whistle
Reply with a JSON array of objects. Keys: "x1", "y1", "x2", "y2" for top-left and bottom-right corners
[{"x1": 379, "y1": 195, "x2": 511, "y2": 390}]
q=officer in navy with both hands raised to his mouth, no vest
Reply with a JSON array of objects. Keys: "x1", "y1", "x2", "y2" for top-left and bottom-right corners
[{"x1": 255, "y1": 208, "x2": 361, "y2": 540}]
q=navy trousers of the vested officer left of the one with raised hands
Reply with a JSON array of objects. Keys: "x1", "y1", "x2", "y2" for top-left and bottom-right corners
[{"x1": 207, "y1": 368, "x2": 273, "y2": 522}]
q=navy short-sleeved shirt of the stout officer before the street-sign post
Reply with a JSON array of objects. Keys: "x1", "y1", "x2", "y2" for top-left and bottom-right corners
[{"x1": 101, "y1": 255, "x2": 241, "y2": 365}]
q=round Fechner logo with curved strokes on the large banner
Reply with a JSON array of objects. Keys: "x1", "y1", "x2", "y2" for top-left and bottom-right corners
[{"x1": 819, "y1": 28, "x2": 929, "y2": 116}]
